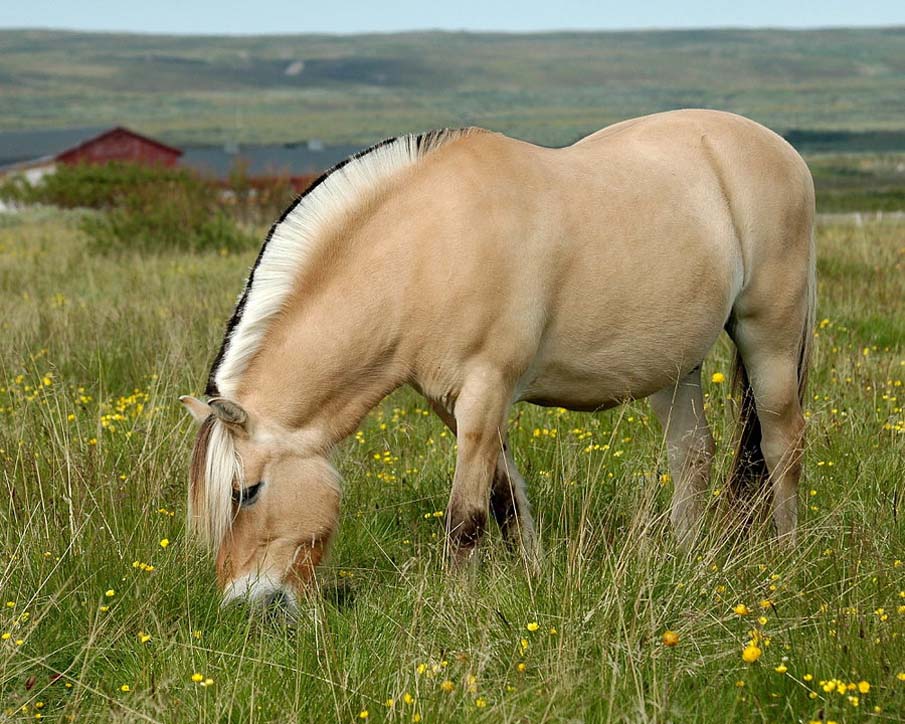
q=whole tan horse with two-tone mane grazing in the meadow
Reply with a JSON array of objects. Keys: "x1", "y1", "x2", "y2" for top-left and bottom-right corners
[{"x1": 181, "y1": 110, "x2": 815, "y2": 603}]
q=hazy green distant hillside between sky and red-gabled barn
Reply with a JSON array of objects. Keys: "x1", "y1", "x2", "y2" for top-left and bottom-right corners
[{"x1": 0, "y1": 28, "x2": 905, "y2": 150}]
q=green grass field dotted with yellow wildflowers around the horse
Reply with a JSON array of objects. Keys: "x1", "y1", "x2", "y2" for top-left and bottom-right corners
[{"x1": 0, "y1": 206, "x2": 905, "y2": 722}]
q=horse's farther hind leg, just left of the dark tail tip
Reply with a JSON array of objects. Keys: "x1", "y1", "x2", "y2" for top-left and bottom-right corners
[{"x1": 650, "y1": 367, "x2": 714, "y2": 547}]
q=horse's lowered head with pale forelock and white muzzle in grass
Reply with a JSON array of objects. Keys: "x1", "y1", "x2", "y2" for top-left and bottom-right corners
[{"x1": 180, "y1": 397, "x2": 340, "y2": 607}]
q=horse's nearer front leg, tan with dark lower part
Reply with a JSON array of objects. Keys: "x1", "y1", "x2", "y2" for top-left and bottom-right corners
[{"x1": 446, "y1": 371, "x2": 511, "y2": 564}]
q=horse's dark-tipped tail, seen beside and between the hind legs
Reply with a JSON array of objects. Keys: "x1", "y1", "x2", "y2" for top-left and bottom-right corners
[{"x1": 727, "y1": 229, "x2": 817, "y2": 501}]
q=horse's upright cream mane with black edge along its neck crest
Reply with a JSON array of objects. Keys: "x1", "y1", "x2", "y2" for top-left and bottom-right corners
[{"x1": 205, "y1": 128, "x2": 481, "y2": 397}]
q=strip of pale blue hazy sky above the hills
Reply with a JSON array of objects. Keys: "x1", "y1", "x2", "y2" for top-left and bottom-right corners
[{"x1": 0, "y1": 0, "x2": 905, "y2": 34}]
